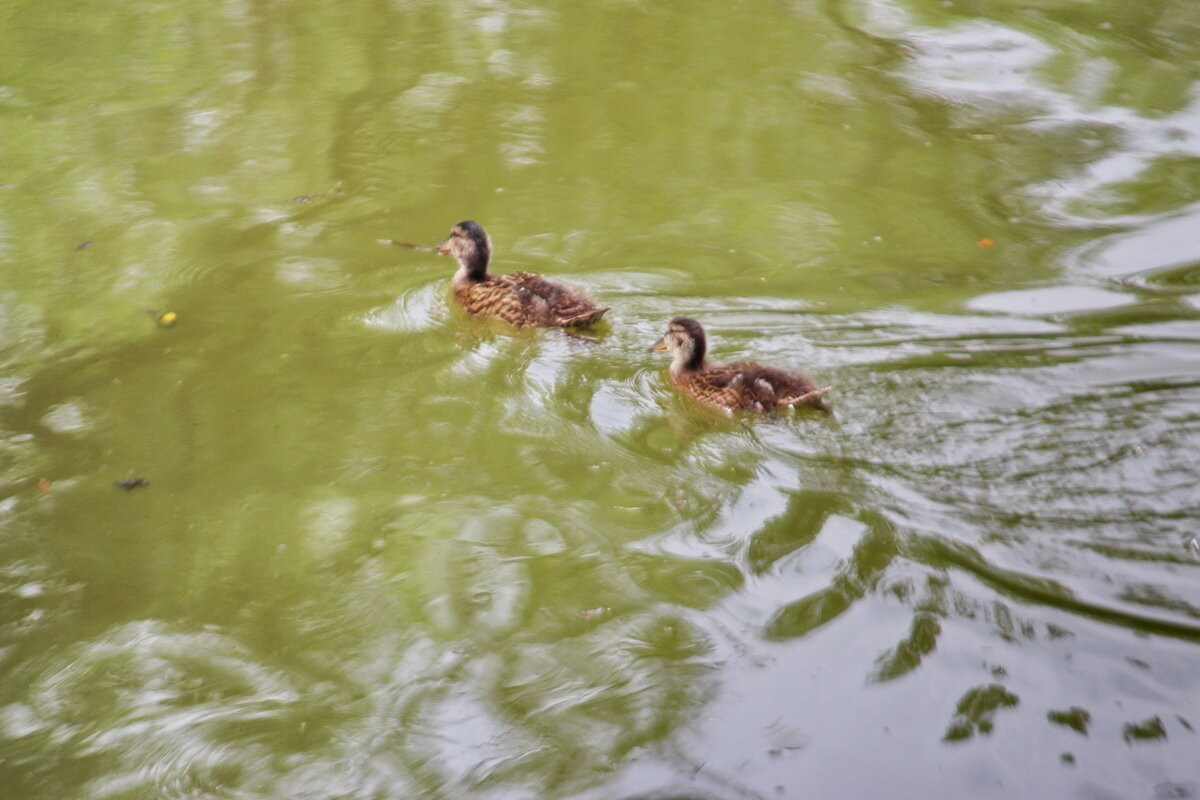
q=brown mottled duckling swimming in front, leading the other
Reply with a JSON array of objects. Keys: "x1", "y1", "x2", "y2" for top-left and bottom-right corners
[{"x1": 438, "y1": 221, "x2": 611, "y2": 327}]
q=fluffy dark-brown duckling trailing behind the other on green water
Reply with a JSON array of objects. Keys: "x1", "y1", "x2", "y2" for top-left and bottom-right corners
[{"x1": 650, "y1": 317, "x2": 833, "y2": 414}]
